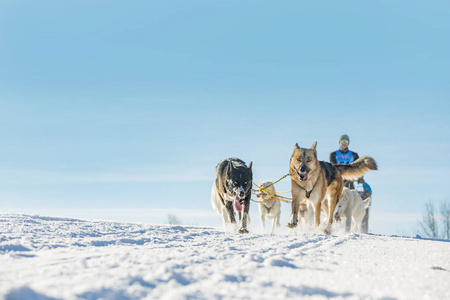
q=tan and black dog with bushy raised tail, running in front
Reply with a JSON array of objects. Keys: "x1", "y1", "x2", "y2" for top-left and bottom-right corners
[{"x1": 287, "y1": 142, "x2": 378, "y2": 234}]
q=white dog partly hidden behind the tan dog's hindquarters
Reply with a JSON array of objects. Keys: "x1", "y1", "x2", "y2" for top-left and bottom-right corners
[{"x1": 334, "y1": 187, "x2": 370, "y2": 233}]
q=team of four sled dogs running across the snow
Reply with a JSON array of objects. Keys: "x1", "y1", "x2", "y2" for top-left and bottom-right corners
[{"x1": 211, "y1": 142, "x2": 378, "y2": 234}]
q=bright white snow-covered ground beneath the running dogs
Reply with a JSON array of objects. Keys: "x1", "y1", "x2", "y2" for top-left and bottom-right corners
[{"x1": 0, "y1": 214, "x2": 450, "y2": 299}]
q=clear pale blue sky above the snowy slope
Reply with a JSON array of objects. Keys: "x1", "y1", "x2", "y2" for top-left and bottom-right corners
[{"x1": 0, "y1": 1, "x2": 450, "y2": 235}]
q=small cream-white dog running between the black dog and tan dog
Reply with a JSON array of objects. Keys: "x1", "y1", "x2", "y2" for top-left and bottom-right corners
[{"x1": 256, "y1": 180, "x2": 281, "y2": 233}]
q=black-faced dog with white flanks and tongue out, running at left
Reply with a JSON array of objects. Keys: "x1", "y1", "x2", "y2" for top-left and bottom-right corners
[{"x1": 211, "y1": 157, "x2": 253, "y2": 233}]
